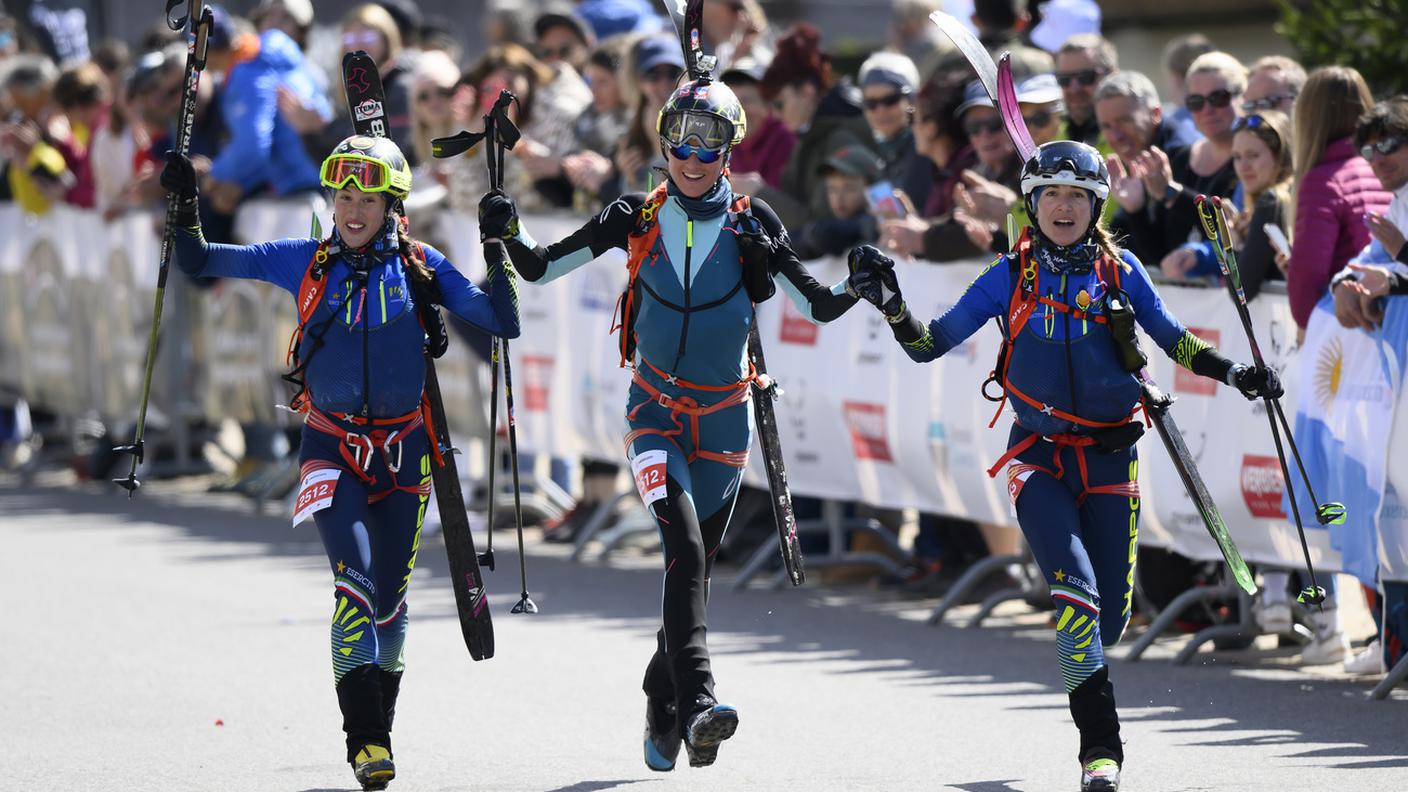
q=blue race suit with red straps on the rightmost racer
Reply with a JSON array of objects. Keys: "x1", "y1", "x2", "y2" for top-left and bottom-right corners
[{"x1": 895, "y1": 231, "x2": 1231, "y2": 762}]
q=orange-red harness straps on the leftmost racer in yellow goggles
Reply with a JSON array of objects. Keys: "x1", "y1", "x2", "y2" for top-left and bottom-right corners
[{"x1": 283, "y1": 238, "x2": 446, "y2": 490}]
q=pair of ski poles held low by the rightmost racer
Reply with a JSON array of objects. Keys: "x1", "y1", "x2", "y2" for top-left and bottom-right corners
[{"x1": 1197, "y1": 196, "x2": 1347, "y2": 605}]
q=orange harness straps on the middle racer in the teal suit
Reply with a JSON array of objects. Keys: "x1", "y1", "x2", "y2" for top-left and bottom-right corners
[{"x1": 611, "y1": 183, "x2": 760, "y2": 468}]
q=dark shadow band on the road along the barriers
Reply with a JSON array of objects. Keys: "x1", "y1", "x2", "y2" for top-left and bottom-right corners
[{"x1": 11, "y1": 479, "x2": 1408, "y2": 777}]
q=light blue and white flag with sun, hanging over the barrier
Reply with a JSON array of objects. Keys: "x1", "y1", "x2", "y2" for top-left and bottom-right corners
[{"x1": 1283, "y1": 295, "x2": 1408, "y2": 586}]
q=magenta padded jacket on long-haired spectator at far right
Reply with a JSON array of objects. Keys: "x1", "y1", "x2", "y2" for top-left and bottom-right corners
[{"x1": 1286, "y1": 138, "x2": 1393, "y2": 327}]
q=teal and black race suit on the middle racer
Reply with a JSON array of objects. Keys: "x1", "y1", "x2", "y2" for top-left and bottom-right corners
[{"x1": 504, "y1": 178, "x2": 856, "y2": 720}]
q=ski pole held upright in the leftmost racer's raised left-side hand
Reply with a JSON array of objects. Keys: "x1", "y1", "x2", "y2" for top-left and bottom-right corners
[{"x1": 113, "y1": 0, "x2": 215, "y2": 497}]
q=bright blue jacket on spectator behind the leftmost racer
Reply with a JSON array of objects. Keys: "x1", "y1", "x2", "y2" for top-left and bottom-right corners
[{"x1": 210, "y1": 30, "x2": 332, "y2": 194}]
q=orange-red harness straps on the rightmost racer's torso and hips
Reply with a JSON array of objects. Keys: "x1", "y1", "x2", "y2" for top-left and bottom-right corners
[{"x1": 981, "y1": 227, "x2": 1143, "y2": 503}]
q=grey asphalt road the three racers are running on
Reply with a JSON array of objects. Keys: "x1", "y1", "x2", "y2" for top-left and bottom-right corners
[{"x1": 0, "y1": 481, "x2": 1408, "y2": 792}]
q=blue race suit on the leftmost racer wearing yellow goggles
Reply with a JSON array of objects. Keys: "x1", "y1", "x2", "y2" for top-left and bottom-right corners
[{"x1": 175, "y1": 218, "x2": 518, "y2": 761}]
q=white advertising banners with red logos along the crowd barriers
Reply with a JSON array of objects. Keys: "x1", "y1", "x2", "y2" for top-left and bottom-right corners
[{"x1": 0, "y1": 203, "x2": 1408, "y2": 579}]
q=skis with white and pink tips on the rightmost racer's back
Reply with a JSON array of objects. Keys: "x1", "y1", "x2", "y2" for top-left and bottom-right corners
[{"x1": 929, "y1": 11, "x2": 1272, "y2": 591}]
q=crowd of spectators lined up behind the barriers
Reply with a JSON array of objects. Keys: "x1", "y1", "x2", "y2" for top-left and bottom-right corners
[{"x1": 0, "y1": 0, "x2": 1408, "y2": 679}]
